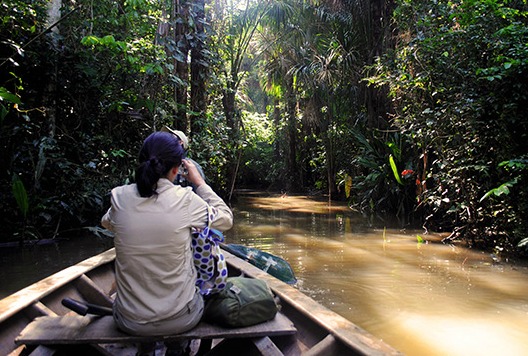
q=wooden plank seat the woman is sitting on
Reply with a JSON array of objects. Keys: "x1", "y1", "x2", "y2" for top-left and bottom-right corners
[{"x1": 15, "y1": 313, "x2": 297, "y2": 349}]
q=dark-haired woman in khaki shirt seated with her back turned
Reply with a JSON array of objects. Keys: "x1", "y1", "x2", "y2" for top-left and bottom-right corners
[{"x1": 101, "y1": 132, "x2": 233, "y2": 348}]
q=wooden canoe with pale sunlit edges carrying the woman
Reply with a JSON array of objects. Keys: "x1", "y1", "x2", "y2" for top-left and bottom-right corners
[{"x1": 0, "y1": 249, "x2": 400, "y2": 356}]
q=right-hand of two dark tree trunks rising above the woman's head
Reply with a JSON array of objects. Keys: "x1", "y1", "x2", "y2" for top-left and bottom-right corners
[{"x1": 191, "y1": 0, "x2": 208, "y2": 134}]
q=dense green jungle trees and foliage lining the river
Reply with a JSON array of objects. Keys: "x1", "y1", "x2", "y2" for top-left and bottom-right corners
[{"x1": 0, "y1": 0, "x2": 528, "y2": 253}]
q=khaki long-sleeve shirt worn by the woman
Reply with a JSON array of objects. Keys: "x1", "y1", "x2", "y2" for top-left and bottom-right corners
[{"x1": 101, "y1": 178, "x2": 233, "y2": 323}]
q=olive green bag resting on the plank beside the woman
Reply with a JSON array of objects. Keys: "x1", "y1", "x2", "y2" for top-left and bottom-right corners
[{"x1": 204, "y1": 277, "x2": 279, "y2": 327}]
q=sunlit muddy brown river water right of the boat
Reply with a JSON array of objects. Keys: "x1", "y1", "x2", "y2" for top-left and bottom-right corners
[{"x1": 231, "y1": 195, "x2": 528, "y2": 355}]
